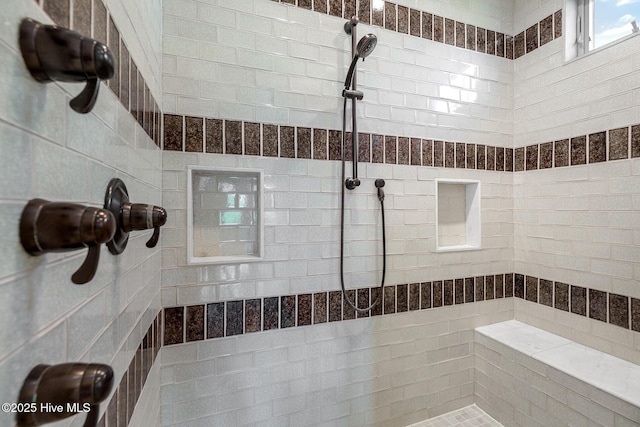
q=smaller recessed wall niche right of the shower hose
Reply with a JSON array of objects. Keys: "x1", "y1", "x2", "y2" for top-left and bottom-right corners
[{"x1": 436, "y1": 179, "x2": 481, "y2": 252}]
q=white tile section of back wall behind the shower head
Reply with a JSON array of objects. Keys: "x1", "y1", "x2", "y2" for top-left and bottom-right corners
[{"x1": 163, "y1": 0, "x2": 513, "y2": 147}]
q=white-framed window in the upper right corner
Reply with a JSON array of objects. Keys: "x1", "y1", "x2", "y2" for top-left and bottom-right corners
[{"x1": 566, "y1": 0, "x2": 640, "y2": 59}]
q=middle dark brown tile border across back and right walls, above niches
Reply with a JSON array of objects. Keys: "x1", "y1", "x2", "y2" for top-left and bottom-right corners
[{"x1": 164, "y1": 114, "x2": 640, "y2": 172}]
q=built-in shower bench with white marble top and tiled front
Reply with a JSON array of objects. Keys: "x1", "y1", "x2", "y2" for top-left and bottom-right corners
[{"x1": 475, "y1": 320, "x2": 640, "y2": 427}]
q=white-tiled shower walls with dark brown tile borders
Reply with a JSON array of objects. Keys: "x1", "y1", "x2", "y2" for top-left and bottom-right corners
[{"x1": 0, "y1": 0, "x2": 640, "y2": 426}]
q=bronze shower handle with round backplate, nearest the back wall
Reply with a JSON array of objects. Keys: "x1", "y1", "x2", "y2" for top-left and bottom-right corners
[{"x1": 104, "y1": 178, "x2": 167, "y2": 255}]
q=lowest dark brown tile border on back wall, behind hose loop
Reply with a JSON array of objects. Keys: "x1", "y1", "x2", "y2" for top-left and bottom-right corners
[{"x1": 163, "y1": 273, "x2": 514, "y2": 345}]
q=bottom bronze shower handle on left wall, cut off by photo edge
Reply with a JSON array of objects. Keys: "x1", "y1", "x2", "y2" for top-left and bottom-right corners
[{"x1": 16, "y1": 363, "x2": 113, "y2": 427}]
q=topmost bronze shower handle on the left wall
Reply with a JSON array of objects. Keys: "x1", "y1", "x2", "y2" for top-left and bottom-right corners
[{"x1": 20, "y1": 18, "x2": 116, "y2": 114}]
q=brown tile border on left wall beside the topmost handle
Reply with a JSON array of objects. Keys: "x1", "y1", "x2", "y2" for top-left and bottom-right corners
[{"x1": 36, "y1": 0, "x2": 162, "y2": 147}]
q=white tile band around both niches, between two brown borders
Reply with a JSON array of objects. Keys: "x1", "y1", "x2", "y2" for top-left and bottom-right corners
[{"x1": 162, "y1": 151, "x2": 512, "y2": 305}]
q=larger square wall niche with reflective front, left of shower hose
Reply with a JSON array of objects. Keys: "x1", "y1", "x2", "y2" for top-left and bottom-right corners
[{"x1": 187, "y1": 166, "x2": 264, "y2": 265}]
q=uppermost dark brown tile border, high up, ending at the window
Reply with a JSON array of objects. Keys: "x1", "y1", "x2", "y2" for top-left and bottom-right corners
[{"x1": 272, "y1": 0, "x2": 562, "y2": 59}]
